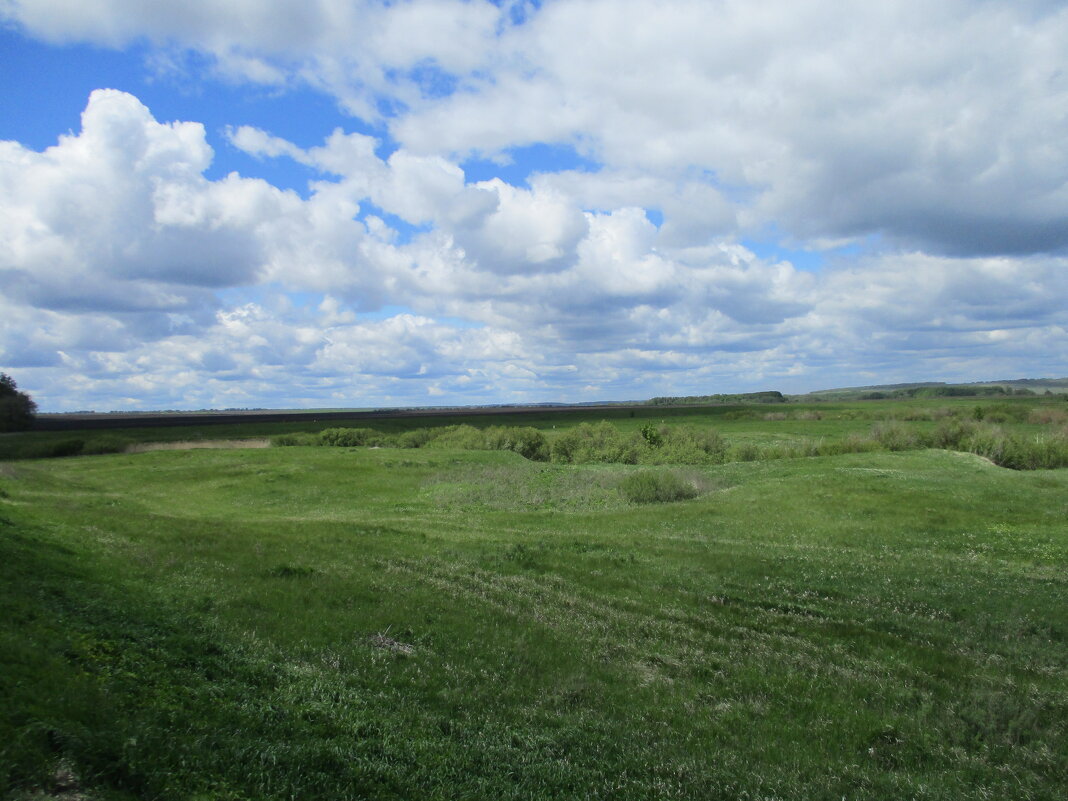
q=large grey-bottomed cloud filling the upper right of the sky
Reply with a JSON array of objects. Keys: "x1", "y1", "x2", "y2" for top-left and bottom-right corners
[{"x1": 393, "y1": 0, "x2": 1068, "y2": 255}]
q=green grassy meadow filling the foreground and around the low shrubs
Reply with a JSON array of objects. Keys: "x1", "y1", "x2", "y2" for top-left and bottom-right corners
[{"x1": 0, "y1": 402, "x2": 1068, "y2": 800}]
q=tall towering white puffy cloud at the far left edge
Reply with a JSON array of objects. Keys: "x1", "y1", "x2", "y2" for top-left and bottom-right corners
[{"x1": 0, "y1": 90, "x2": 275, "y2": 313}]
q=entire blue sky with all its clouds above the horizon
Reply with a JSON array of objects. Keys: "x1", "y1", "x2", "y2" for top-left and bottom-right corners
[{"x1": 0, "y1": 0, "x2": 1068, "y2": 411}]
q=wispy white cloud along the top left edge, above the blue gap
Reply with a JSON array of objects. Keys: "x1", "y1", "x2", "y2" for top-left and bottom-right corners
[{"x1": 0, "y1": 0, "x2": 508, "y2": 117}]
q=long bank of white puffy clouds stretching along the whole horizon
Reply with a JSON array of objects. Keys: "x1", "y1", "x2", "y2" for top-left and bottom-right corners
[{"x1": 6, "y1": 75, "x2": 1068, "y2": 408}]
